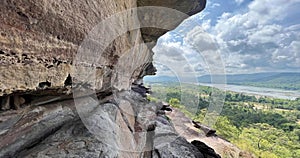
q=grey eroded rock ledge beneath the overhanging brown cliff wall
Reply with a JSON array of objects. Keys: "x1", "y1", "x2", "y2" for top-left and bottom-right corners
[{"x1": 0, "y1": 91, "x2": 216, "y2": 158}]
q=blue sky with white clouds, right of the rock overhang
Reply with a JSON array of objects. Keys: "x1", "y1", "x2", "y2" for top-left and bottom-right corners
[{"x1": 153, "y1": 0, "x2": 300, "y2": 76}]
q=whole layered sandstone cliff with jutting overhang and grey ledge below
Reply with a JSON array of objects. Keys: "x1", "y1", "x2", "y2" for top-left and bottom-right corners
[{"x1": 0, "y1": 0, "x2": 223, "y2": 158}]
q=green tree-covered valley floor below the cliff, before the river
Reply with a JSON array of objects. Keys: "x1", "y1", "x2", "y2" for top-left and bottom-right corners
[{"x1": 152, "y1": 83, "x2": 300, "y2": 158}]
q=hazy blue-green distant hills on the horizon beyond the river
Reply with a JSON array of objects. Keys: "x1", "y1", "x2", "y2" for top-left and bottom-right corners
[{"x1": 144, "y1": 72, "x2": 300, "y2": 90}]
